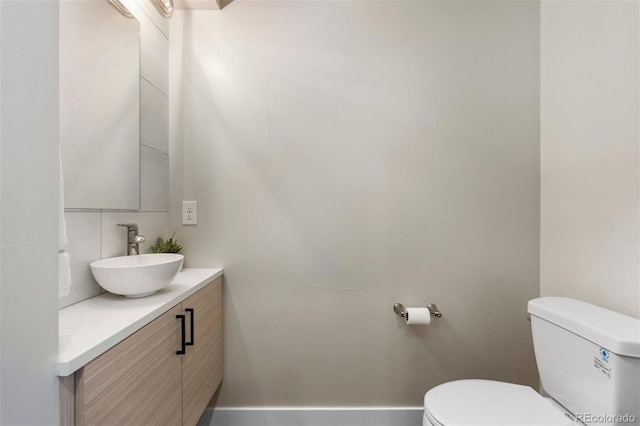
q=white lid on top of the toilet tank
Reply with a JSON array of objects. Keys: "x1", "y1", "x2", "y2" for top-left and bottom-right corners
[{"x1": 528, "y1": 297, "x2": 640, "y2": 358}]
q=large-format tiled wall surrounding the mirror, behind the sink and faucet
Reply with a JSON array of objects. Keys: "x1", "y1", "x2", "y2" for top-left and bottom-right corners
[{"x1": 59, "y1": 0, "x2": 171, "y2": 307}]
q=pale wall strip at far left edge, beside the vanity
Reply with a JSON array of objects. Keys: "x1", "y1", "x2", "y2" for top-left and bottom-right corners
[{"x1": 0, "y1": 0, "x2": 58, "y2": 425}]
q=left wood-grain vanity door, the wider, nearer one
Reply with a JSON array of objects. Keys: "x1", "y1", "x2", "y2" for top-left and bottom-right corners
[{"x1": 75, "y1": 305, "x2": 182, "y2": 426}]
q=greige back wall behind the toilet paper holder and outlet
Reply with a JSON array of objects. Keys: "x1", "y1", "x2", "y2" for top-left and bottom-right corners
[{"x1": 170, "y1": 1, "x2": 540, "y2": 406}]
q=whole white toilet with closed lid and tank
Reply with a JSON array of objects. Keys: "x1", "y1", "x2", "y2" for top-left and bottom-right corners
[{"x1": 422, "y1": 297, "x2": 640, "y2": 426}]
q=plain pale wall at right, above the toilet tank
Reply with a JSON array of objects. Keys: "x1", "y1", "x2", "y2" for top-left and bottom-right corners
[{"x1": 540, "y1": 1, "x2": 640, "y2": 318}]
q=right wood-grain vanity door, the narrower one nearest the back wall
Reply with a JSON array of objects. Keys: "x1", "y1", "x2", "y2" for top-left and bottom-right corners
[{"x1": 182, "y1": 278, "x2": 222, "y2": 425}]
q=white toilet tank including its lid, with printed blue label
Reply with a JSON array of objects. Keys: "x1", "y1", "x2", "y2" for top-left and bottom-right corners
[{"x1": 528, "y1": 297, "x2": 640, "y2": 425}]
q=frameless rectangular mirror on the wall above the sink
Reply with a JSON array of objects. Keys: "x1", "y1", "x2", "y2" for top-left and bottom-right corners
[{"x1": 60, "y1": 0, "x2": 140, "y2": 210}]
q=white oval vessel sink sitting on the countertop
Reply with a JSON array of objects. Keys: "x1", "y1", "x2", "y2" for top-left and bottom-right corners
[{"x1": 91, "y1": 253, "x2": 184, "y2": 297}]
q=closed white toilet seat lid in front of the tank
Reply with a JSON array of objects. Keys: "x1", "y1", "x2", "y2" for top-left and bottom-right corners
[{"x1": 424, "y1": 380, "x2": 575, "y2": 426}]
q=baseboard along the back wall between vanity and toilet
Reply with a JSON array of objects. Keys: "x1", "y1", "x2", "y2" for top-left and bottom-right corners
[{"x1": 198, "y1": 407, "x2": 423, "y2": 426}]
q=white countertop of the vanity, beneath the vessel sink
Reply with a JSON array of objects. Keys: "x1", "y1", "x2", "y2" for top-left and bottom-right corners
[{"x1": 56, "y1": 268, "x2": 224, "y2": 376}]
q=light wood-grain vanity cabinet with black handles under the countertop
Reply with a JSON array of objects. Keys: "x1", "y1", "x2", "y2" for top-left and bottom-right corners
[{"x1": 61, "y1": 270, "x2": 222, "y2": 426}]
